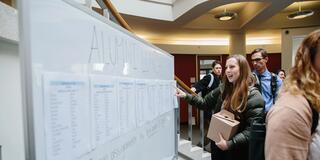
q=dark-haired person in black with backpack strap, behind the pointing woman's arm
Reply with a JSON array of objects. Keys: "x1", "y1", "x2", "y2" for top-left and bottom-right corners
[{"x1": 191, "y1": 60, "x2": 222, "y2": 151}]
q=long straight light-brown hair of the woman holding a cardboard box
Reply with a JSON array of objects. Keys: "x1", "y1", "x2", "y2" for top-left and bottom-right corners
[{"x1": 222, "y1": 55, "x2": 251, "y2": 113}]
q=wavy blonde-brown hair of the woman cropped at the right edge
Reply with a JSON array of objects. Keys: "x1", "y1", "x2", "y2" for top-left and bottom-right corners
[{"x1": 281, "y1": 30, "x2": 320, "y2": 112}]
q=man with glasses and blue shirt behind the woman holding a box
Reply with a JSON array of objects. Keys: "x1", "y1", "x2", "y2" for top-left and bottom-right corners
[{"x1": 251, "y1": 48, "x2": 282, "y2": 112}]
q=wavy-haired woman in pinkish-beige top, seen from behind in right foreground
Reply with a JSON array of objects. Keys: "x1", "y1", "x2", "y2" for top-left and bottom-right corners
[{"x1": 265, "y1": 30, "x2": 320, "y2": 160}]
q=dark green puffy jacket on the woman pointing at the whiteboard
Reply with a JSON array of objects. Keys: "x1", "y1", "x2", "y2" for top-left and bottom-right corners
[{"x1": 185, "y1": 86, "x2": 265, "y2": 150}]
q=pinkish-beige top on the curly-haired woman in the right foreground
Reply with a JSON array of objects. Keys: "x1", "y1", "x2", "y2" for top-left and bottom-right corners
[{"x1": 265, "y1": 92, "x2": 312, "y2": 159}]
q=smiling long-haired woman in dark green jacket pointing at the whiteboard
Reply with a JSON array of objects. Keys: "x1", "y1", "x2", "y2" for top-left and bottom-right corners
[{"x1": 176, "y1": 55, "x2": 264, "y2": 160}]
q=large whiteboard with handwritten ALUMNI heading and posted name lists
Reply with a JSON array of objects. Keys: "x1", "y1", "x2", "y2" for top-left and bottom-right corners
[{"x1": 19, "y1": 0, "x2": 177, "y2": 160}]
